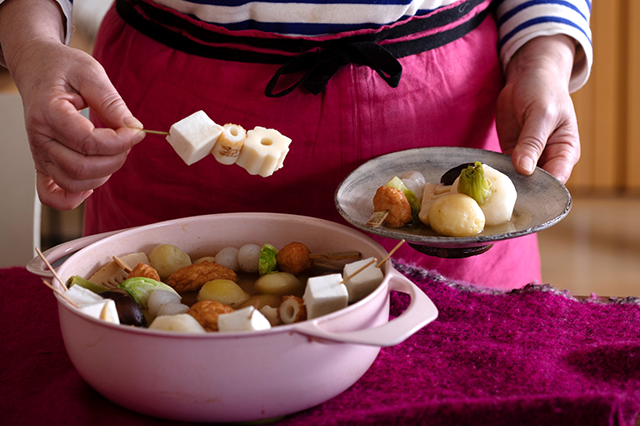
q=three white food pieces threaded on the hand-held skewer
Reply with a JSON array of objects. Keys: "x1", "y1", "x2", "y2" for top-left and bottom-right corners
[{"x1": 167, "y1": 110, "x2": 291, "y2": 177}]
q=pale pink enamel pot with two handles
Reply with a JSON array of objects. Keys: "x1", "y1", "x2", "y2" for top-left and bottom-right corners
[{"x1": 27, "y1": 213, "x2": 438, "y2": 422}]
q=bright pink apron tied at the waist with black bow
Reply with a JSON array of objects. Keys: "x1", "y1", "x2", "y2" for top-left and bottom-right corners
[{"x1": 85, "y1": 0, "x2": 540, "y2": 289}]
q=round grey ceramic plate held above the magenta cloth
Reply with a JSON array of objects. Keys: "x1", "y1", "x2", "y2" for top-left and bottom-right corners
[{"x1": 335, "y1": 147, "x2": 571, "y2": 258}]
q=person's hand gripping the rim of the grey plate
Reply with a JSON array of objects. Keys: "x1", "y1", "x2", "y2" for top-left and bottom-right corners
[{"x1": 496, "y1": 35, "x2": 580, "y2": 183}]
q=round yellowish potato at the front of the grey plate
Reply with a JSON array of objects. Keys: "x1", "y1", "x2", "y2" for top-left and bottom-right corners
[{"x1": 429, "y1": 193, "x2": 485, "y2": 237}]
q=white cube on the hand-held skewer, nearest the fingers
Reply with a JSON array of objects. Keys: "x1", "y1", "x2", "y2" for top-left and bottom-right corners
[{"x1": 167, "y1": 111, "x2": 222, "y2": 166}]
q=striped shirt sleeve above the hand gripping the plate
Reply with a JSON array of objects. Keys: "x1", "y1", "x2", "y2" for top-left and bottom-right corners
[{"x1": 496, "y1": 0, "x2": 593, "y2": 92}]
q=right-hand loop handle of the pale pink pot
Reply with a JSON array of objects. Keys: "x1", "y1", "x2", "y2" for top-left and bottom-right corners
[{"x1": 294, "y1": 268, "x2": 438, "y2": 346}]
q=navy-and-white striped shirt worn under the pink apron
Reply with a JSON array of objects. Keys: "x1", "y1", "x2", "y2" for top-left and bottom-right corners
[{"x1": 53, "y1": 0, "x2": 593, "y2": 92}]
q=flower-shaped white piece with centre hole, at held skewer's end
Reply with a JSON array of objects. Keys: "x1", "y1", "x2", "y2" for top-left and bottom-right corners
[{"x1": 236, "y1": 126, "x2": 291, "y2": 177}]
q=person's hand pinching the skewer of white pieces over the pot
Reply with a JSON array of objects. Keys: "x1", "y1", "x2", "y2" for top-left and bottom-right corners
[{"x1": 0, "y1": 0, "x2": 144, "y2": 210}]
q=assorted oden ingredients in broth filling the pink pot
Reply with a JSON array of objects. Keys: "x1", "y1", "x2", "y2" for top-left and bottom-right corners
[{"x1": 66, "y1": 242, "x2": 384, "y2": 333}]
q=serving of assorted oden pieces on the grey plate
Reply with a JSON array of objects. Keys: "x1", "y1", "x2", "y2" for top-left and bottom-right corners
[{"x1": 369, "y1": 162, "x2": 517, "y2": 237}]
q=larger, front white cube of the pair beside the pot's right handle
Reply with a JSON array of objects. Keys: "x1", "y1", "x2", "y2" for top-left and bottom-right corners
[{"x1": 302, "y1": 274, "x2": 349, "y2": 319}]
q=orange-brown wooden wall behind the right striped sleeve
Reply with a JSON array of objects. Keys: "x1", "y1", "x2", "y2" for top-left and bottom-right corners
[{"x1": 567, "y1": 0, "x2": 640, "y2": 194}]
